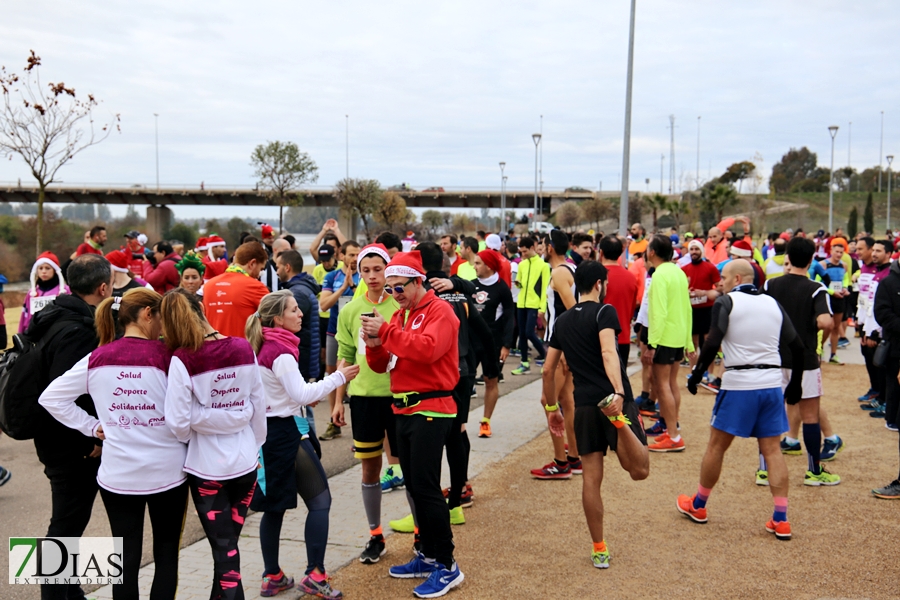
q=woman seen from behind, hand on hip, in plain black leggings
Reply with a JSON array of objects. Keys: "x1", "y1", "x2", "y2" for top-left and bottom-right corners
[{"x1": 39, "y1": 288, "x2": 188, "y2": 600}]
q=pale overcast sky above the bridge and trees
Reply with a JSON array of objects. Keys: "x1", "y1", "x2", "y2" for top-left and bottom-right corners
[{"x1": 0, "y1": 0, "x2": 900, "y2": 217}]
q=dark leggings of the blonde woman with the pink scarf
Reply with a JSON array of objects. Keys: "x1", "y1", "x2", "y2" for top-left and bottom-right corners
[{"x1": 259, "y1": 439, "x2": 331, "y2": 576}]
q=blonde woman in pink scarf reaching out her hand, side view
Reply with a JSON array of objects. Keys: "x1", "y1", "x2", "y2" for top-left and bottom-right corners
[{"x1": 244, "y1": 290, "x2": 359, "y2": 598}]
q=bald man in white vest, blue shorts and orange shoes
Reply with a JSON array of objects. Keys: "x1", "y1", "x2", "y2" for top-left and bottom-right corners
[{"x1": 676, "y1": 258, "x2": 804, "y2": 540}]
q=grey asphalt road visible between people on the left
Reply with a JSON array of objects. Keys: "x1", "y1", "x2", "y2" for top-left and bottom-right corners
[{"x1": 0, "y1": 357, "x2": 540, "y2": 600}]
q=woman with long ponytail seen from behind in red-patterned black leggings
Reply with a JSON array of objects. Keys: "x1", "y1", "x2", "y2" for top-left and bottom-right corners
[{"x1": 160, "y1": 288, "x2": 266, "y2": 600}]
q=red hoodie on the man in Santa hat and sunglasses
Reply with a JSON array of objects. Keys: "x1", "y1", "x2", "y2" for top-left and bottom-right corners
[{"x1": 366, "y1": 290, "x2": 459, "y2": 416}]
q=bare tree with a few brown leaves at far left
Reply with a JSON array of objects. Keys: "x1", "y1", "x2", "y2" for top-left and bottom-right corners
[{"x1": 0, "y1": 50, "x2": 120, "y2": 255}]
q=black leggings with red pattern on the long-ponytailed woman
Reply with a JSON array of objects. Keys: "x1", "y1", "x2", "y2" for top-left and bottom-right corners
[{"x1": 188, "y1": 470, "x2": 256, "y2": 600}]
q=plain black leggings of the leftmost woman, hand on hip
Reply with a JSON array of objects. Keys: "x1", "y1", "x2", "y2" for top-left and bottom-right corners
[{"x1": 100, "y1": 481, "x2": 188, "y2": 600}]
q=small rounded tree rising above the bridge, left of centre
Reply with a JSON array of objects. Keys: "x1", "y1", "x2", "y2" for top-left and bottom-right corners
[{"x1": 250, "y1": 141, "x2": 319, "y2": 233}]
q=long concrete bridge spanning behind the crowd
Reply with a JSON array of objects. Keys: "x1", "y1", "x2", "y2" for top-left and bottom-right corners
[{"x1": 0, "y1": 184, "x2": 619, "y2": 239}]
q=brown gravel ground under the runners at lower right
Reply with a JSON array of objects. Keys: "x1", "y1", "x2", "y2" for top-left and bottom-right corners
[{"x1": 333, "y1": 365, "x2": 900, "y2": 600}]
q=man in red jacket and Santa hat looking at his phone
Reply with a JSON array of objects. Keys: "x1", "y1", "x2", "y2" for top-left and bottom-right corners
[{"x1": 361, "y1": 251, "x2": 464, "y2": 598}]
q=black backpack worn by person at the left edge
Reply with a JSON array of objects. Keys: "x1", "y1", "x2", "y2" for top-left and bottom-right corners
[{"x1": 0, "y1": 318, "x2": 80, "y2": 440}]
